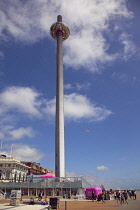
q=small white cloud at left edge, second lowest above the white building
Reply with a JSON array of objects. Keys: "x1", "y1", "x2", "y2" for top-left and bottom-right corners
[{"x1": 0, "y1": 125, "x2": 34, "y2": 140}]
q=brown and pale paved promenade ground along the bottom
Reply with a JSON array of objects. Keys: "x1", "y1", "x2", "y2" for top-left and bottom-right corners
[{"x1": 0, "y1": 197, "x2": 140, "y2": 210}]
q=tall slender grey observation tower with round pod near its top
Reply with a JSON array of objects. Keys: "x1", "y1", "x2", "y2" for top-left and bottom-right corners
[{"x1": 50, "y1": 15, "x2": 70, "y2": 177}]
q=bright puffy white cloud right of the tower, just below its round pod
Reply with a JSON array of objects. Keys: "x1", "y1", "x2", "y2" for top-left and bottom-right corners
[{"x1": 64, "y1": 29, "x2": 116, "y2": 71}]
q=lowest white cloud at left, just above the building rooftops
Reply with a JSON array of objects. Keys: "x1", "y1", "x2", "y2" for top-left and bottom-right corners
[{"x1": 4, "y1": 144, "x2": 44, "y2": 162}]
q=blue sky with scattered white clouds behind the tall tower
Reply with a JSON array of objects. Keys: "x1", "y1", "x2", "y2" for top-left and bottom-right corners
[{"x1": 0, "y1": 0, "x2": 140, "y2": 189}]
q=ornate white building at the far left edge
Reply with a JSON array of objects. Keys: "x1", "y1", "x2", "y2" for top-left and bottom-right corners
[{"x1": 0, "y1": 155, "x2": 29, "y2": 182}]
